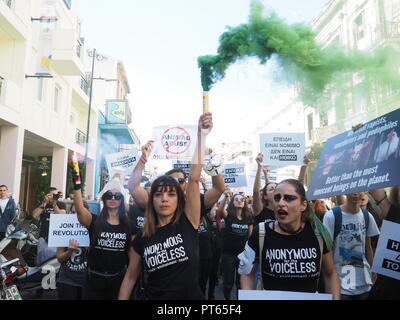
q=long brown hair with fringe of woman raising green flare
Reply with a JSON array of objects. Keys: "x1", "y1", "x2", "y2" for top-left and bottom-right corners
[{"x1": 143, "y1": 175, "x2": 185, "y2": 238}]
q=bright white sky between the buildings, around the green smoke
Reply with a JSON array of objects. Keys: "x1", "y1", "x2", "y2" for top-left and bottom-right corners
[{"x1": 76, "y1": 0, "x2": 328, "y2": 145}]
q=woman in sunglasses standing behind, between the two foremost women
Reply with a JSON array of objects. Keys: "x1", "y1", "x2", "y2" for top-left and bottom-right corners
[{"x1": 217, "y1": 193, "x2": 253, "y2": 300}]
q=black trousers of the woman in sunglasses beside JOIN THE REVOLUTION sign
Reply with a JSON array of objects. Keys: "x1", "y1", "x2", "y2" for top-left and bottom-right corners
[{"x1": 82, "y1": 270, "x2": 125, "y2": 300}]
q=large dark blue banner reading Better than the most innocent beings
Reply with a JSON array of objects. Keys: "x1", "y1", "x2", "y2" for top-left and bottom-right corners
[{"x1": 307, "y1": 109, "x2": 400, "y2": 200}]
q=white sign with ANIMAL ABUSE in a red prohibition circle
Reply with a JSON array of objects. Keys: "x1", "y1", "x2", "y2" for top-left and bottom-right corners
[{"x1": 151, "y1": 125, "x2": 197, "y2": 160}]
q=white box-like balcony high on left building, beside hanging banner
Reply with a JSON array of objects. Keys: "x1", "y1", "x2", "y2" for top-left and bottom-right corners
[{"x1": 52, "y1": 29, "x2": 85, "y2": 76}]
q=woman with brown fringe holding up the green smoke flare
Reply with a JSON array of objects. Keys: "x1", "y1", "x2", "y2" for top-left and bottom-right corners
[{"x1": 119, "y1": 113, "x2": 213, "y2": 300}]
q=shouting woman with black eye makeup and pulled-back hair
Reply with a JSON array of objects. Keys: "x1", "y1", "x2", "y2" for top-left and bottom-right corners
[{"x1": 239, "y1": 179, "x2": 340, "y2": 300}]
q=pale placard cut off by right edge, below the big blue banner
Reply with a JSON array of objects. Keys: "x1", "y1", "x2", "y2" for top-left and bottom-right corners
[{"x1": 371, "y1": 220, "x2": 400, "y2": 280}]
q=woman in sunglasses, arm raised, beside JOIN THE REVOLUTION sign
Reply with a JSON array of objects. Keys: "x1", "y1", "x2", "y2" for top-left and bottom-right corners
[{"x1": 72, "y1": 178, "x2": 131, "y2": 300}]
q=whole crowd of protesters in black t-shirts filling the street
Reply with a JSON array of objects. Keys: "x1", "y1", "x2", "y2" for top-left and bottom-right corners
[{"x1": 4, "y1": 113, "x2": 400, "y2": 300}]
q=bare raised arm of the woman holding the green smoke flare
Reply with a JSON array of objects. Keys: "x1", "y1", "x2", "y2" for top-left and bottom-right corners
[{"x1": 185, "y1": 113, "x2": 213, "y2": 229}]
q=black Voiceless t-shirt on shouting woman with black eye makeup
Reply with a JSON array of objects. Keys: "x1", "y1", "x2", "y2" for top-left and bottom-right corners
[{"x1": 248, "y1": 223, "x2": 328, "y2": 292}]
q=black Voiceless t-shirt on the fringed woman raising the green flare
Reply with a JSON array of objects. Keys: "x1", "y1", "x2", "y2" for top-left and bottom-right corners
[{"x1": 132, "y1": 213, "x2": 201, "y2": 300}]
